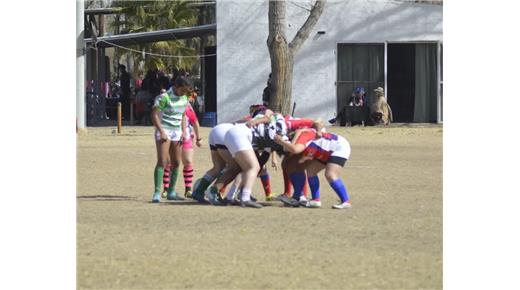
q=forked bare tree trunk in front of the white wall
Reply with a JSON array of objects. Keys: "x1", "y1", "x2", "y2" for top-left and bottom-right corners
[{"x1": 267, "y1": 0, "x2": 325, "y2": 115}]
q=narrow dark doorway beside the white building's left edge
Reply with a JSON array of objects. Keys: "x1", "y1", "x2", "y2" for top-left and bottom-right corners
[{"x1": 204, "y1": 46, "x2": 217, "y2": 112}]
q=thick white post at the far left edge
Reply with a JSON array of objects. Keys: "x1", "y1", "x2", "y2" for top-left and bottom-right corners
[{"x1": 76, "y1": 0, "x2": 86, "y2": 129}]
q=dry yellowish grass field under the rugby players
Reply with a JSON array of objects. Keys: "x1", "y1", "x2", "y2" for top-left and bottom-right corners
[{"x1": 77, "y1": 125, "x2": 443, "y2": 289}]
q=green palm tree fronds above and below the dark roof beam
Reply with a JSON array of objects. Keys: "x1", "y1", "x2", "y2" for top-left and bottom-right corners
[{"x1": 112, "y1": 1, "x2": 198, "y2": 75}]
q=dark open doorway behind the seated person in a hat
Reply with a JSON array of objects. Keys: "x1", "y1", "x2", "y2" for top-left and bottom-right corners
[{"x1": 387, "y1": 43, "x2": 415, "y2": 122}]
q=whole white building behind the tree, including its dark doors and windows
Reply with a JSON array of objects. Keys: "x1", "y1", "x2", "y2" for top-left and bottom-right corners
[{"x1": 216, "y1": 0, "x2": 443, "y2": 123}]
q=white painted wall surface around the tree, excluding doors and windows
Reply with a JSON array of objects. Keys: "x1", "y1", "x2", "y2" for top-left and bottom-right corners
[{"x1": 217, "y1": 0, "x2": 442, "y2": 123}]
